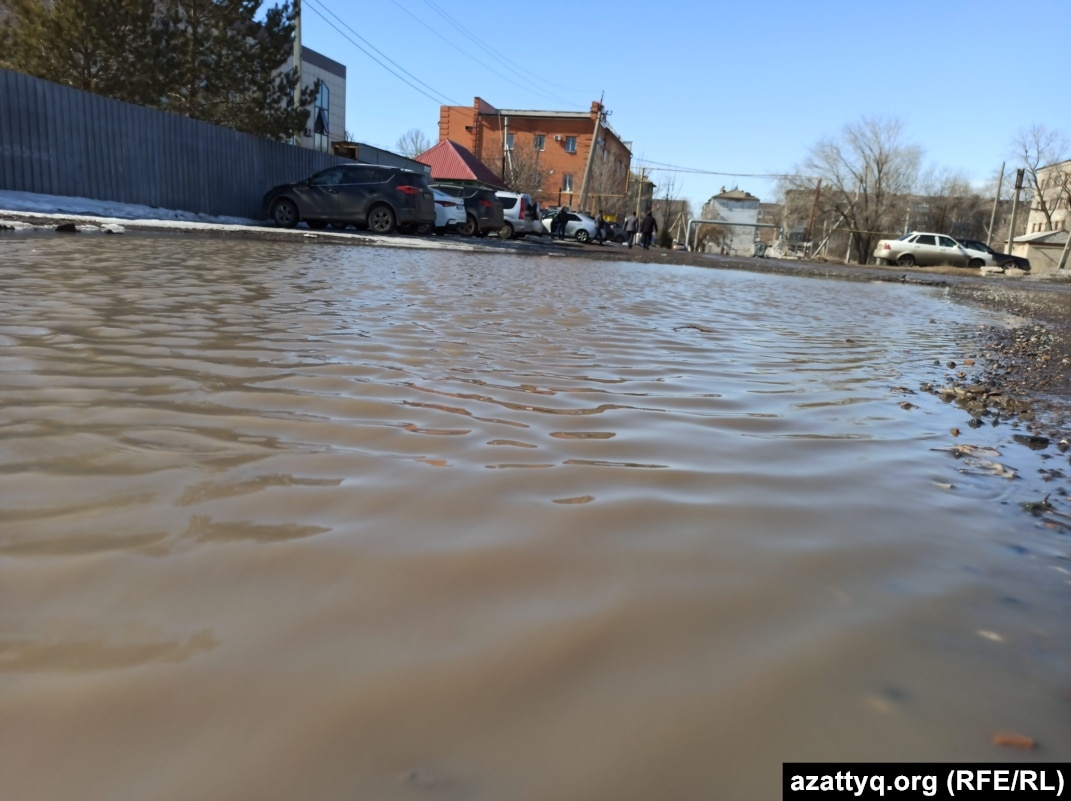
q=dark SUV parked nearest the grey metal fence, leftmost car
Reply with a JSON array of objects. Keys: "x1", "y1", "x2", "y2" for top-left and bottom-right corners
[{"x1": 263, "y1": 164, "x2": 435, "y2": 233}]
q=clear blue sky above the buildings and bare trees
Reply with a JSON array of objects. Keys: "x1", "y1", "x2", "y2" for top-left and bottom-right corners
[{"x1": 302, "y1": 0, "x2": 1071, "y2": 212}]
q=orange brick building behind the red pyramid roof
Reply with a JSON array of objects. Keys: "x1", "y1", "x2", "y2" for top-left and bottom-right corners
[{"x1": 439, "y1": 97, "x2": 632, "y2": 214}]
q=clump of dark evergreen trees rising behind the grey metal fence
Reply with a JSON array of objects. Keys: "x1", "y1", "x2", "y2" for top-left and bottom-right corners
[{"x1": 0, "y1": 0, "x2": 318, "y2": 140}]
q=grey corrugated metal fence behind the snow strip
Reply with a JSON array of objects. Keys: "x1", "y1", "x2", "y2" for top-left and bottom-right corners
[{"x1": 0, "y1": 70, "x2": 350, "y2": 217}]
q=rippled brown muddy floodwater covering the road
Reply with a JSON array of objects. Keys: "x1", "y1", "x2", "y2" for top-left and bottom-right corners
[{"x1": 0, "y1": 235, "x2": 1071, "y2": 801}]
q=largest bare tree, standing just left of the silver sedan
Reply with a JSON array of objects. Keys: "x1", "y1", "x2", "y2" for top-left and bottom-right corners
[{"x1": 785, "y1": 117, "x2": 922, "y2": 263}]
